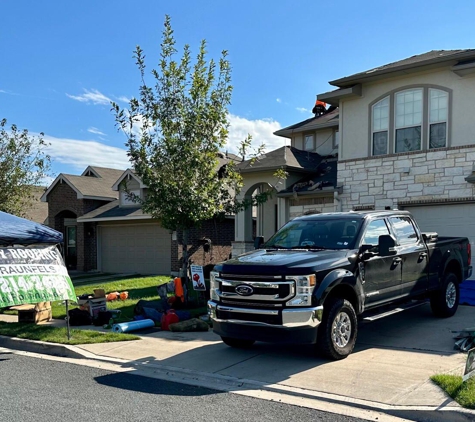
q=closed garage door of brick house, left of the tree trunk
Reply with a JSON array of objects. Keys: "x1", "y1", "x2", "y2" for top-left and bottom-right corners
[{"x1": 99, "y1": 224, "x2": 171, "y2": 275}]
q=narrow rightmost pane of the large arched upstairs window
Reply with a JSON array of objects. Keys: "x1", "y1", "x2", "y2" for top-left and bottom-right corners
[{"x1": 429, "y1": 88, "x2": 449, "y2": 148}]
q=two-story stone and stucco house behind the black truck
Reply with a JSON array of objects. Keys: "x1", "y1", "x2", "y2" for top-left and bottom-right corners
[{"x1": 235, "y1": 50, "x2": 475, "y2": 266}]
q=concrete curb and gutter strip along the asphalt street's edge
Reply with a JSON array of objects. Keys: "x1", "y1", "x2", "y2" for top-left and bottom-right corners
[{"x1": 0, "y1": 336, "x2": 475, "y2": 422}]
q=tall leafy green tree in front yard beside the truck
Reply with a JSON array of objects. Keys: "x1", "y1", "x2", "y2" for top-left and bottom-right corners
[{"x1": 112, "y1": 16, "x2": 280, "y2": 286}]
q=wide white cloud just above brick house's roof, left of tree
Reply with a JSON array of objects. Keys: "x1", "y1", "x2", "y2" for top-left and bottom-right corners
[{"x1": 44, "y1": 135, "x2": 130, "y2": 172}]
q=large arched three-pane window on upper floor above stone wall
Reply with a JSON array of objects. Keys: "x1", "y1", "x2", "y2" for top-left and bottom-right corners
[{"x1": 371, "y1": 87, "x2": 450, "y2": 156}]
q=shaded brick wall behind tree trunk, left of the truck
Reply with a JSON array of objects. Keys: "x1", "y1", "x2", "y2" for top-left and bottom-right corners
[{"x1": 171, "y1": 219, "x2": 234, "y2": 273}]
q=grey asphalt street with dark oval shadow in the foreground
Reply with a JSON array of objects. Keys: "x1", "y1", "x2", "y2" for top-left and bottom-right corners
[{"x1": 0, "y1": 349, "x2": 370, "y2": 422}]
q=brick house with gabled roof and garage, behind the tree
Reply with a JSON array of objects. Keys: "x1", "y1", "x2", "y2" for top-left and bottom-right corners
[{"x1": 42, "y1": 163, "x2": 234, "y2": 275}]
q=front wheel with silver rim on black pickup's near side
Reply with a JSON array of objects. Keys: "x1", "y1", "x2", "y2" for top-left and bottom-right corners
[{"x1": 317, "y1": 298, "x2": 358, "y2": 360}]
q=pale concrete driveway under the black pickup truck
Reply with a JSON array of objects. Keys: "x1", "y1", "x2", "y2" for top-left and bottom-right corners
[{"x1": 0, "y1": 304, "x2": 475, "y2": 421}]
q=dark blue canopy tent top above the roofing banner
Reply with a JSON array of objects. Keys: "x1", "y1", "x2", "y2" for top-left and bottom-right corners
[{"x1": 0, "y1": 211, "x2": 63, "y2": 246}]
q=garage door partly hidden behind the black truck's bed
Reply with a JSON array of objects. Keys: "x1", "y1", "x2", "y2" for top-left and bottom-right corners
[{"x1": 404, "y1": 204, "x2": 475, "y2": 279}]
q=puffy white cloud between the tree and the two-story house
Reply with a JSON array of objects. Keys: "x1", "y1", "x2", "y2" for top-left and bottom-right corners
[{"x1": 225, "y1": 114, "x2": 285, "y2": 154}]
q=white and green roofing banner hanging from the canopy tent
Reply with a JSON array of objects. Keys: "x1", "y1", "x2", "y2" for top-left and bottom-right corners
[{"x1": 0, "y1": 245, "x2": 77, "y2": 308}]
